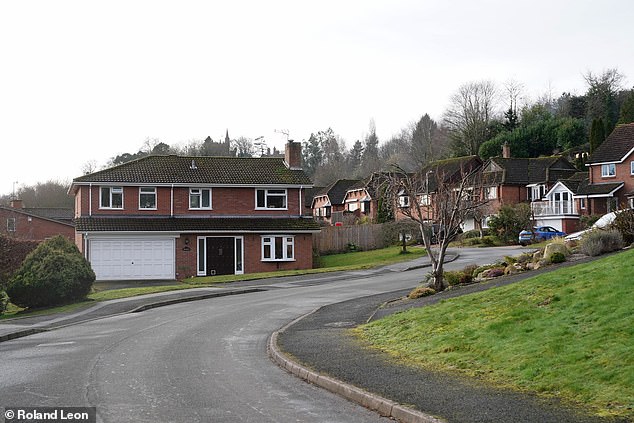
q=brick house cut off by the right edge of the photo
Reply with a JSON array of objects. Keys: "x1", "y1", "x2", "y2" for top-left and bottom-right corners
[{"x1": 575, "y1": 123, "x2": 634, "y2": 214}]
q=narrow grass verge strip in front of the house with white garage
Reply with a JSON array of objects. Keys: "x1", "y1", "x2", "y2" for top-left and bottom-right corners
[{"x1": 0, "y1": 247, "x2": 426, "y2": 319}]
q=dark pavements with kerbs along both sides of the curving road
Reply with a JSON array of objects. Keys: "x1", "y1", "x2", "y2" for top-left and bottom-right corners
[{"x1": 0, "y1": 252, "x2": 624, "y2": 423}]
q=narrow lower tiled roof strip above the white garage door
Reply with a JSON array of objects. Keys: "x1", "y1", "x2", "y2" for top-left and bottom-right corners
[{"x1": 75, "y1": 217, "x2": 319, "y2": 233}]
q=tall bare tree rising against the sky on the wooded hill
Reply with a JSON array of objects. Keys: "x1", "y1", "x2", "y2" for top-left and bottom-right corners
[{"x1": 444, "y1": 81, "x2": 497, "y2": 156}]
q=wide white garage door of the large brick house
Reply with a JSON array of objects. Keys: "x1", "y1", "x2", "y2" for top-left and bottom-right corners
[{"x1": 90, "y1": 238, "x2": 175, "y2": 280}]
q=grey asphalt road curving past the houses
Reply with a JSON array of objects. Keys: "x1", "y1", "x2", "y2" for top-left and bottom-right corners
[{"x1": 0, "y1": 249, "x2": 528, "y2": 422}]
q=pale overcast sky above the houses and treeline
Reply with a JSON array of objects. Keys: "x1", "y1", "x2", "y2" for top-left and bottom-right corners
[{"x1": 0, "y1": 0, "x2": 634, "y2": 194}]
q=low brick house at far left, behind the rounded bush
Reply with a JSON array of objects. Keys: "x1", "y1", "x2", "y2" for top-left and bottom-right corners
[{"x1": 0, "y1": 200, "x2": 75, "y2": 241}]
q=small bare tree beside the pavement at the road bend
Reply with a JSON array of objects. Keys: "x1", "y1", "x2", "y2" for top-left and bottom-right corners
[{"x1": 383, "y1": 160, "x2": 487, "y2": 291}]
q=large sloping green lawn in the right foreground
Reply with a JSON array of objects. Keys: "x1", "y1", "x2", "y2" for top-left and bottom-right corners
[{"x1": 355, "y1": 250, "x2": 634, "y2": 418}]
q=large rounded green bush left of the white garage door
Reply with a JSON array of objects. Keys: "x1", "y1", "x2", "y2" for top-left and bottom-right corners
[{"x1": 7, "y1": 236, "x2": 95, "y2": 308}]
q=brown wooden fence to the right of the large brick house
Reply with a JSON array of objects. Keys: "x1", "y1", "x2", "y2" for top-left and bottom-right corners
[{"x1": 313, "y1": 224, "x2": 386, "y2": 254}]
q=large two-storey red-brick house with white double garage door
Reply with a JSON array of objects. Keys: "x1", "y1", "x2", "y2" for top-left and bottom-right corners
[{"x1": 71, "y1": 142, "x2": 319, "y2": 280}]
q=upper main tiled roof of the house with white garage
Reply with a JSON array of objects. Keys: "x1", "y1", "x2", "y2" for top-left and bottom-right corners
[{"x1": 73, "y1": 155, "x2": 312, "y2": 185}]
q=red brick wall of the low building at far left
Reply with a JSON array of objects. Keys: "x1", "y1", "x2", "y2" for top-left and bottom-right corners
[{"x1": 0, "y1": 209, "x2": 75, "y2": 241}]
